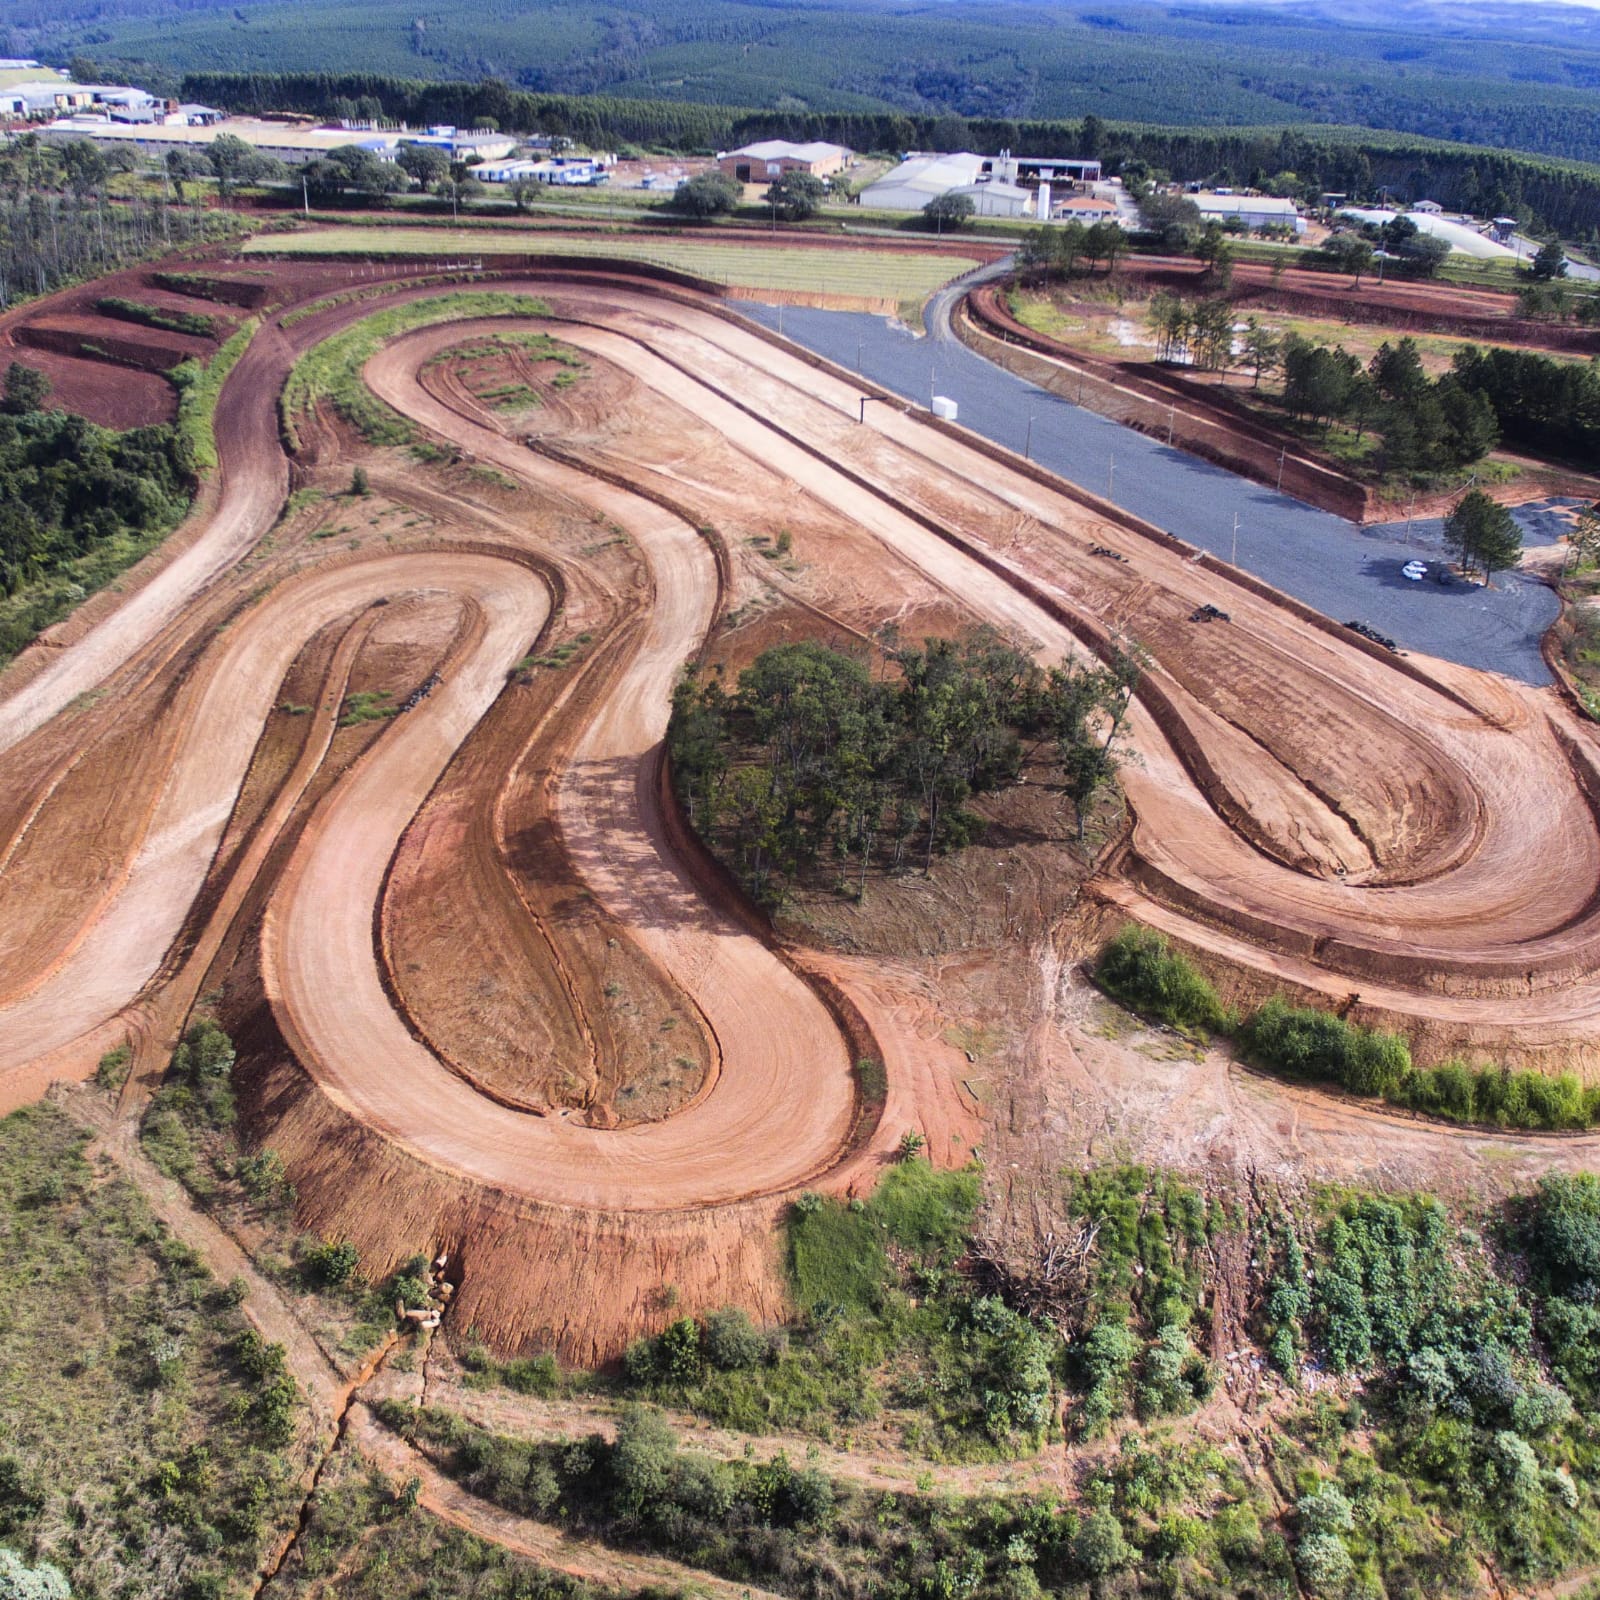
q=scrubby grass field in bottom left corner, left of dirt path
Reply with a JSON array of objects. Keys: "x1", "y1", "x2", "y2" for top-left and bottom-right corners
[{"x1": 0, "y1": 1104, "x2": 302, "y2": 1600}]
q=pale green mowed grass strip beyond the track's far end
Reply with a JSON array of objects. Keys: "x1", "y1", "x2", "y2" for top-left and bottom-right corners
[{"x1": 245, "y1": 227, "x2": 978, "y2": 301}]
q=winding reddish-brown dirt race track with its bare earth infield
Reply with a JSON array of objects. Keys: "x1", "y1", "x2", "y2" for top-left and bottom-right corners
[{"x1": 9, "y1": 267, "x2": 1600, "y2": 1360}]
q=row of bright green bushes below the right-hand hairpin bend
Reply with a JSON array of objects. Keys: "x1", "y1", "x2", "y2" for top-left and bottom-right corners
[{"x1": 1094, "y1": 926, "x2": 1600, "y2": 1130}]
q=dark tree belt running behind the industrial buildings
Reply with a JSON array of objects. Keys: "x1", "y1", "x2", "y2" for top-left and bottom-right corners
[{"x1": 116, "y1": 72, "x2": 1600, "y2": 238}]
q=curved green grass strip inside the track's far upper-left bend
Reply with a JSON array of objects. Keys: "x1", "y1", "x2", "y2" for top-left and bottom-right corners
[{"x1": 280, "y1": 290, "x2": 549, "y2": 450}]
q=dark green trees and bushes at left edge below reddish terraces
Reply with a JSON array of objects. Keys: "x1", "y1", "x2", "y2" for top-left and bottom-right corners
[{"x1": 0, "y1": 362, "x2": 200, "y2": 664}]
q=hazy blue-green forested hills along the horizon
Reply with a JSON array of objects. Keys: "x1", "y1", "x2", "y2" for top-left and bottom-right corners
[{"x1": 15, "y1": 0, "x2": 1600, "y2": 158}]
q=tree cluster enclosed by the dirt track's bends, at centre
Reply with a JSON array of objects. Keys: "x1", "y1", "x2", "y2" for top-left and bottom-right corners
[{"x1": 667, "y1": 630, "x2": 1139, "y2": 904}]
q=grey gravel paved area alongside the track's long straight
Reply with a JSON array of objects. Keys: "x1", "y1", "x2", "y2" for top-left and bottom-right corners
[{"x1": 741, "y1": 290, "x2": 1560, "y2": 683}]
